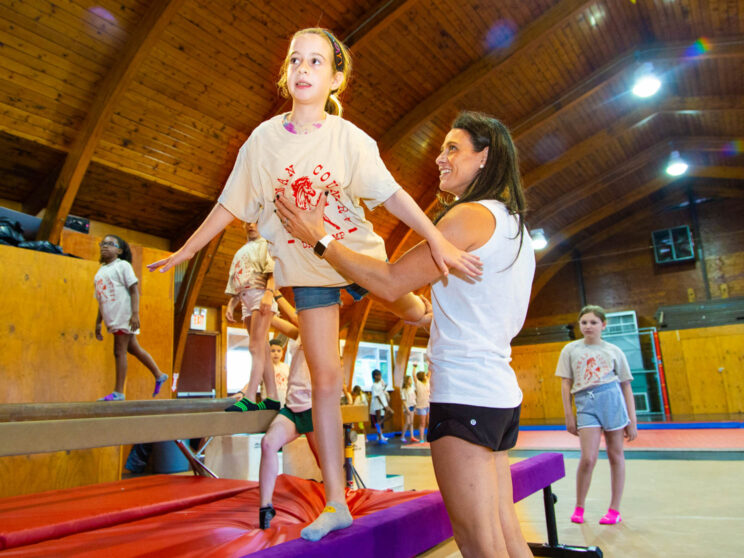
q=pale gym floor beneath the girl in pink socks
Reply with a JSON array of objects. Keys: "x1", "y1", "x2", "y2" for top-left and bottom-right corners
[{"x1": 387, "y1": 455, "x2": 744, "y2": 558}]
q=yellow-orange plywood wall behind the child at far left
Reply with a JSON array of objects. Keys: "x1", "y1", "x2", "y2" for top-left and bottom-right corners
[{"x1": 0, "y1": 231, "x2": 173, "y2": 497}]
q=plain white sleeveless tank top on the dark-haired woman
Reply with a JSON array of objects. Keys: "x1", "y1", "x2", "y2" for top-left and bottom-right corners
[{"x1": 427, "y1": 200, "x2": 535, "y2": 408}]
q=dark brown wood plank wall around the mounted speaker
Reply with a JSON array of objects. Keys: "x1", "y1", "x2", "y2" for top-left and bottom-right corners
[{"x1": 525, "y1": 199, "x2": 744, "y2": 327}]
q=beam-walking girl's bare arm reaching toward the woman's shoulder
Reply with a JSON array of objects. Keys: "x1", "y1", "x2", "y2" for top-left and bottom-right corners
[{"x1": 383, "y1": 188, "x2": 482, "y2": 277}]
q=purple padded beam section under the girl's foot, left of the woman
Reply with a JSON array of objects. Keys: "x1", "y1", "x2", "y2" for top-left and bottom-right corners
[{"x1": 250, "y1": 492, "x2": 452, "y2": 558}]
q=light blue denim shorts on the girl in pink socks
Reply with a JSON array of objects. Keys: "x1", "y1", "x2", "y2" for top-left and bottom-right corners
[{"x1": 574, "y1": 382, "x2": 630, "y2": 431}]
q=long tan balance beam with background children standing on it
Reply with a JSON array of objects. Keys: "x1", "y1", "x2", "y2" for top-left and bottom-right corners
[{"x1": 0, "y1": 399, "x2": 369, "y2": 457}]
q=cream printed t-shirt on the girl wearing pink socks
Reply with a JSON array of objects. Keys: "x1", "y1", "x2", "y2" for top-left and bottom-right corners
[{"x1": 555, "y1": 339, "x2": 633, "y2": 393}]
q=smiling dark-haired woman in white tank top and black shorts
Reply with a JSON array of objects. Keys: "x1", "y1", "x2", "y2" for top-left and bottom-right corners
[{"x1": 277, "y1": 112, "x2": 535, "y2": 558}]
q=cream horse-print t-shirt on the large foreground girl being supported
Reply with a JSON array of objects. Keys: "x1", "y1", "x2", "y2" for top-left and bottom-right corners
[{"x1": 218, "y1": 115, "x2": 400, "y2": 287}]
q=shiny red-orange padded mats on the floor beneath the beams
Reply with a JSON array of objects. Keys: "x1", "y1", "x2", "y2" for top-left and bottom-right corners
[{"x1": 0, "y1": 475, "x2": 436, "y2": 558}]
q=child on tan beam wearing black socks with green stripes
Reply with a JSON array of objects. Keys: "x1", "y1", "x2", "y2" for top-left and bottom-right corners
[{"x1": 225, "y1": 223, "x2": 280, "y2": 412}]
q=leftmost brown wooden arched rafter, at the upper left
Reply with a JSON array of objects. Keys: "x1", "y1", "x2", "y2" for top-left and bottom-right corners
[{"x1": 37, "y1": 0, "x2": 184, "y2": 244}]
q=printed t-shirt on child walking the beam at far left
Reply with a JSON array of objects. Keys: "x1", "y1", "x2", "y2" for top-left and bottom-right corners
[{"x1": 94, "y1": 258, "x2": 139, "y2": 333}]
